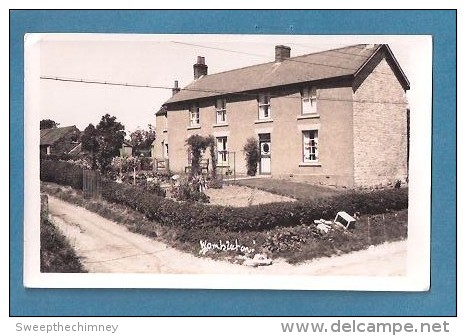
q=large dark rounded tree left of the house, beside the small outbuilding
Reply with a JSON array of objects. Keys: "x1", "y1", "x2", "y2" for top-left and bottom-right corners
[{"x1": 82, "y1": 114, "x2": 125, "y2": 173}]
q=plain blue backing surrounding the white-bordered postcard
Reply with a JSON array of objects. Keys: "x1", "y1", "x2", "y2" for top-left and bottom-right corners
[{"x1": 10, "y1": 10, "x2": 456, "y2": 316}]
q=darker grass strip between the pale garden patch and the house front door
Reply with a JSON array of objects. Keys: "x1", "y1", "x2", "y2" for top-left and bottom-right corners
[{"x1": 232, "y1": 178, "x2": 348, "y2": 200}]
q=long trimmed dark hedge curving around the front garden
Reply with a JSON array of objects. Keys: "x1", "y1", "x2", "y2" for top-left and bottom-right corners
[{"x1": 102, "y1": 182, "x2": 408, "y2": 231}]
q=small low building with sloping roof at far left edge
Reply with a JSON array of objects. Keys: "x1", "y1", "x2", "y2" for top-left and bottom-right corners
[{"x1": 40, "y1": 125, "x2": 81, "y2": 156}]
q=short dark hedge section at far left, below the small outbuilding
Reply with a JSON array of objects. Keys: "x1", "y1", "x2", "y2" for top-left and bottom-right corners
[{"x1": 40, "y1": 160, "x2": 83, "y2": 189}]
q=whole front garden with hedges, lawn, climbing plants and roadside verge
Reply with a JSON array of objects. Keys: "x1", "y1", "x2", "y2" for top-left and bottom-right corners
[{"x1": 40, "y1": 127, "x2": 408, "y2": 263}]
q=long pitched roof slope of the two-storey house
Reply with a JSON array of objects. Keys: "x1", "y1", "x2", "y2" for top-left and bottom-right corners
[{"x1": 165, "y1": 44, "x2": 409, "y2": 104}]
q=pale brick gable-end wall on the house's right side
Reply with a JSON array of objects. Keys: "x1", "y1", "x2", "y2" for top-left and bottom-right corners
[{"x1": 353, "y1": 58, "x2": 407, "y2": 187}]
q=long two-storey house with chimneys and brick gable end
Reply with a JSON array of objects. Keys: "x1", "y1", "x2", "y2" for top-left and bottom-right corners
[{"x1": 155, "y1": 44, "x2": 410, "y2": 187}]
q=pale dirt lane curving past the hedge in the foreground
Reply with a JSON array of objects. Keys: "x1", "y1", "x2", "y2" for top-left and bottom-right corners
[{"x1": 45, "y1": 196, "x2": 407, "y2": 276}]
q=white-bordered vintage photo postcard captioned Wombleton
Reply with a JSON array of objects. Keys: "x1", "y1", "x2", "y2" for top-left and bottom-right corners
[{"x1": 24, "y1": 34, "x2": 432, "y2": 291}]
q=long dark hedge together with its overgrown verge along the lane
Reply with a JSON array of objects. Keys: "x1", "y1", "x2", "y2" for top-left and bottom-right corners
[{"x1": 42, "y1": 183, "x2": 408, "y2": 263}]
